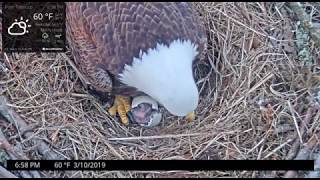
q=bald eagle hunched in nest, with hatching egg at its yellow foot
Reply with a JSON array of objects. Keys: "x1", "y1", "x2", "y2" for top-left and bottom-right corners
[{"x1": 66, "y1": 2, "x2": 207, "y2": 126}]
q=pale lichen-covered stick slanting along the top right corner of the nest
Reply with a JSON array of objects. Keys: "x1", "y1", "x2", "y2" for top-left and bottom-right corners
[{"x1": 289, "y1": 2, "x2": 320, "y2": 47}]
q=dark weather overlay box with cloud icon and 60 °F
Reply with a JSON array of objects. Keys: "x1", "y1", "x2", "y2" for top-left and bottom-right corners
[{"x1": 2, "y1": 2, "x2": 66, "y2": 52}]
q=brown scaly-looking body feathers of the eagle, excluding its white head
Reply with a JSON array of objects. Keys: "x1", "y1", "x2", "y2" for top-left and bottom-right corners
[{"x1": 67, "y1": 2, "x2": 206, "y2": 96}]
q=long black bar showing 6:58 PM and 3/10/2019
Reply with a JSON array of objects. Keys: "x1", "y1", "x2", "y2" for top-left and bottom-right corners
[{"x1": 7, "y1": 160, "x2": 314, "y2": 171}]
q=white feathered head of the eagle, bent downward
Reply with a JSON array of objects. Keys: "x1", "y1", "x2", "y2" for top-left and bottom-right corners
[{"x1": 120, "y1": 40, "x2": 199, "y2": 116}]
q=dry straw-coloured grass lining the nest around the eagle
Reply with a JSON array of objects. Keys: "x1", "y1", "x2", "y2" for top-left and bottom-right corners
[{"x1": 0, "y1": 2, "x2": 320, "y2": 177}]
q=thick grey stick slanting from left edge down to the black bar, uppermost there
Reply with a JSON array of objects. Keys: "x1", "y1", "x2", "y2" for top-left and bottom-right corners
[{"x1": 0, "y1": 96, "x2": 62, "y2": 160}]
